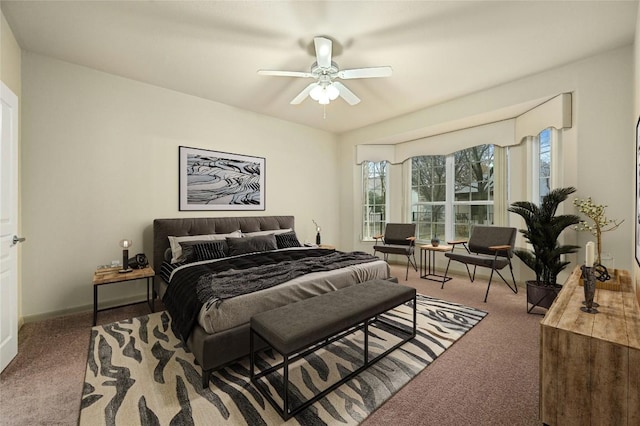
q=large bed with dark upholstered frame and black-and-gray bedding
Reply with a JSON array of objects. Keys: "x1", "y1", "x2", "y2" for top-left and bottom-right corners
[{"x1": 153, "y1": 216, "x2": 392, "y2": 386}]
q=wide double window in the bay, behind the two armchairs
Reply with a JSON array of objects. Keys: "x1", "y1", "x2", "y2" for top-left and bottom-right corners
[{"x1": 411, "y1": 145, "x2": 494, "y2": 241}]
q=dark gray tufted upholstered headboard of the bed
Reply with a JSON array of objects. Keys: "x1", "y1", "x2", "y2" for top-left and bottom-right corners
[{"x1": 153, "y1": 216, "x2": 294, "y2": 271}]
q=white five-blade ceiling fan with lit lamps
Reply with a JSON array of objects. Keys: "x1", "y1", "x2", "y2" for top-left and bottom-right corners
[{"x1": 258, "y1": 37, "x2": 392, "y2": 105}]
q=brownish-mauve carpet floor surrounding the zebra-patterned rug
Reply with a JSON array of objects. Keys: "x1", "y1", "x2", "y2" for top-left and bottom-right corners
[{"x1": 0, "y1": 265, "x2": 542, "y2": 425}]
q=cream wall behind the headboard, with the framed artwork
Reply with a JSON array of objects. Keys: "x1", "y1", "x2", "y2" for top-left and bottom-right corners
[{"x1": 21, "y1": 53, "x2": 339, "y2": 318}]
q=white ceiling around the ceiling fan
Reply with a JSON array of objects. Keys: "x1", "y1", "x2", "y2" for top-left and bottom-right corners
[{"x1": 0, "y1": 0, "x2": 638, "y2": 133}]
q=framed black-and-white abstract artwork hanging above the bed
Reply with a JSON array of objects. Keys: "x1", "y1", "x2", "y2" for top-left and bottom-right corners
[{"x1": 179, "y1": 146, "x2": 265, "y2": 210}]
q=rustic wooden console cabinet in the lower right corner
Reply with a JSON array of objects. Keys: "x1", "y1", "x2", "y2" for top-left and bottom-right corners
[{"x1": 540, "y1": 267, "x2": 640, "y2": 426}]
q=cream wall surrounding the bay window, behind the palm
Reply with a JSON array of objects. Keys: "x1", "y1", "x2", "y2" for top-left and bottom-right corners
[{"x1": 339, "y1": 46, "x2": 635, "y2": 280}]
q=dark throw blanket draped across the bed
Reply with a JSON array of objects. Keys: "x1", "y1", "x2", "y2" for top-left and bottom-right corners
[{"x1": 162, "y1": 249, "x2": 379, "y2": 341}]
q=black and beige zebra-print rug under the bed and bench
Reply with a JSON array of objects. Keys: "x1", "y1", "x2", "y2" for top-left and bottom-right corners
[{"x1": 79, "y1": 295, "x2": 486, "y2": 426}]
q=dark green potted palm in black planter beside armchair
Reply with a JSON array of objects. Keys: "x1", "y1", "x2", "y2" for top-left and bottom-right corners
[{"x1": 508, "y1": 187, "x2": 580, "y2": 312}]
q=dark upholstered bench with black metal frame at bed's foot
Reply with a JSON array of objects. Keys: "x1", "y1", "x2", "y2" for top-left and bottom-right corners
[{"x1": 250, "y1": 280, "x2": 416, "y2": 420}]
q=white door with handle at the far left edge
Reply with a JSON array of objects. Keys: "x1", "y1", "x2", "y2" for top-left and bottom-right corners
[{"x1": 0, "y1": 82, "x2": 18, "y2": 371}]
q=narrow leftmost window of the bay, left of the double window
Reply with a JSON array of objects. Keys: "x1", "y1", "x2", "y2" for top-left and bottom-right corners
[{"x1": 362, "y1": 161, "x2": 389, "y2": 240}]
